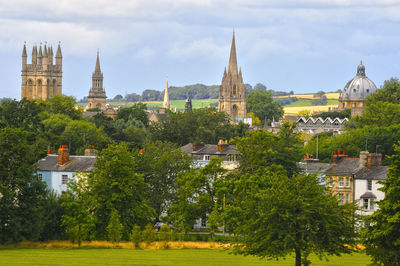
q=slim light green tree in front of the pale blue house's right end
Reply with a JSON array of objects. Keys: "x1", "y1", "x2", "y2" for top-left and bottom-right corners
[{"x1": 61, "y1": 174, "x2": 95, "y2": 247}]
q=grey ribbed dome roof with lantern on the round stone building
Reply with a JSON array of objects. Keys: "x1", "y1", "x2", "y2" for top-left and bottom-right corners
[{"x1": 340, "y1": 62, "x2": 377, "y2": 100}]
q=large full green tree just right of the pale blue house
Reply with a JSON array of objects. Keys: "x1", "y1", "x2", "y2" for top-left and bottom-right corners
[{"x1": 87, "y1": 142, "x2": 154, "y2": 239}]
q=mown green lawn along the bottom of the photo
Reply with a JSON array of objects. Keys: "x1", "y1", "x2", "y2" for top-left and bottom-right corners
[{"x1": 0, "y1": 248, "x2": 371, "y2": 266}]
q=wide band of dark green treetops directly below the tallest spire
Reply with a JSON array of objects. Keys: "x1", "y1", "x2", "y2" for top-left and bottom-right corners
[{"x1": 150, "y1": 109, "x2": 248, "y2": 145}]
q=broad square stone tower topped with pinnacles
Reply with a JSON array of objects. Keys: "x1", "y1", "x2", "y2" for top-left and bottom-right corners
[{"x1": 21, "y1": 43, "x2": 62, "y2": 100}]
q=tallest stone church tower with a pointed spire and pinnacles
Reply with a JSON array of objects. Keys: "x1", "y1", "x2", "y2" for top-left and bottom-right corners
[{"x1": 218, "y1": 32, "x2": 246, "y2": 122}]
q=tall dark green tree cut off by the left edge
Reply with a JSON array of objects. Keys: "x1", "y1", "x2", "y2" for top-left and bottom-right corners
[{"x1": 0, "y1": 127, "x2": 46, "y2": 243}]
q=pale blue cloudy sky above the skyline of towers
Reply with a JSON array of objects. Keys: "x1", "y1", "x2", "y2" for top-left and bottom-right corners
[{"x1": 0, "y1": 0, "x2": 400, "y2": 100}]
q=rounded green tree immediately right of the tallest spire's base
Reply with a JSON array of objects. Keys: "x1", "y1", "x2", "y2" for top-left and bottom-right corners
[{"x1": 246, "y1": 90, "x2": 284, "y2": 122}]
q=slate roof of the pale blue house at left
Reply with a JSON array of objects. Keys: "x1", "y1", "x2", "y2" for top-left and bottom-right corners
[{"x1": 38, "y1": 154, "x2": 96, "y2": 172}]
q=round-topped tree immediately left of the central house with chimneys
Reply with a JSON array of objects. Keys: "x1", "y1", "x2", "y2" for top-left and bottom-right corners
[{"x1": 134, "y1": 141, "x2": 192, "y2": 222}]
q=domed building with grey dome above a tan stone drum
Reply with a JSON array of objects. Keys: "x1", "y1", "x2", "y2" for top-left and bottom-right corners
[{"x1": 339, "y1": 61, "x2": 378, "y2": 116}]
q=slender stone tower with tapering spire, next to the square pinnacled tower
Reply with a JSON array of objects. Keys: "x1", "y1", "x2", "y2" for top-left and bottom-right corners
[{"x1": 86, "y1": 51, "x2": 107, "y2": 109}]
